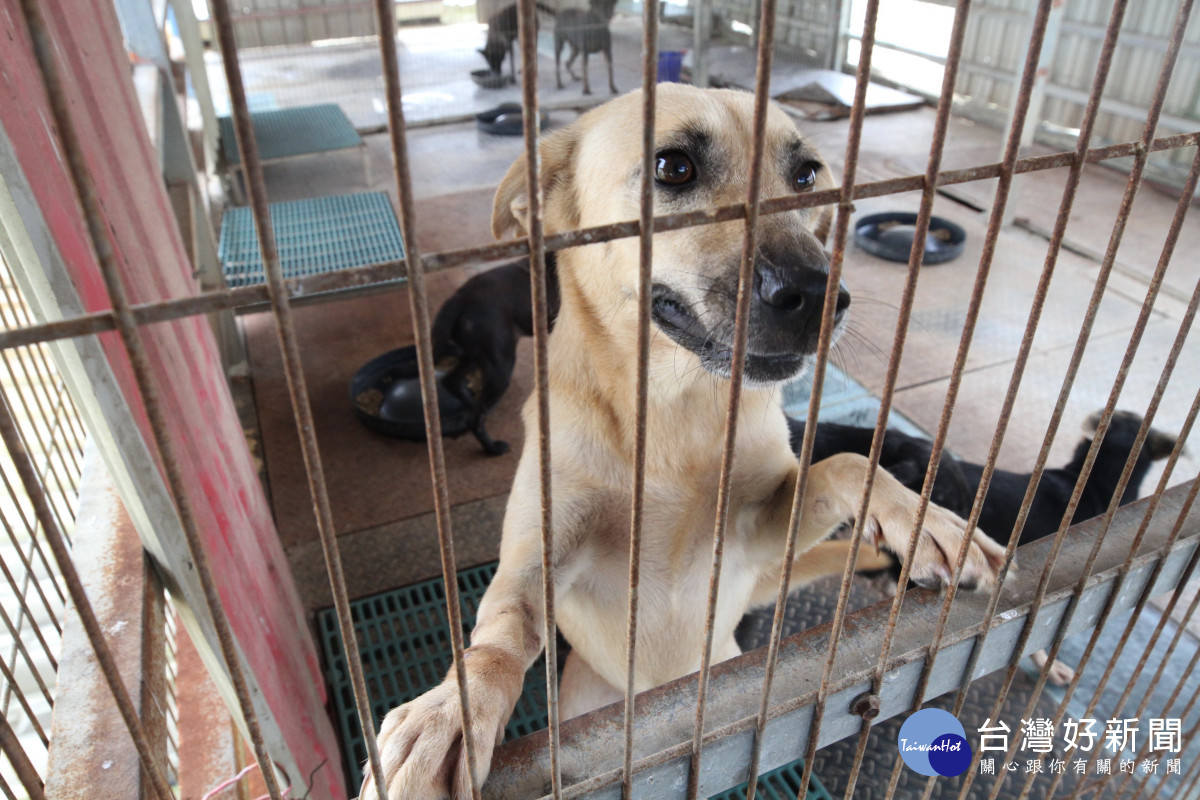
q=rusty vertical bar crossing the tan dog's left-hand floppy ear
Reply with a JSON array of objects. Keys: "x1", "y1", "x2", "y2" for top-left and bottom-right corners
[{"x1": 517, "y1": 0, "x2": 563, "y2": 800}]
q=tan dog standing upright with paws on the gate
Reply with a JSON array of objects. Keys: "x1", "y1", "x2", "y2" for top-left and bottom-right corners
[{"x1": 361, "y1": 84, "x2": 1003, "y2": 800}]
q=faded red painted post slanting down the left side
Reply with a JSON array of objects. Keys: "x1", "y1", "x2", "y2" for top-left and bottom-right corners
[{"x1": 0, "y1": 0, "x2": 344, "y2": 798}]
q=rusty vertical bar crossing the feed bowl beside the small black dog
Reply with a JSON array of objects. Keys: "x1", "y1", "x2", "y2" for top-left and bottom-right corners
[{"x1": 367, "y1": 0, "x2": 480, "y2": 800}]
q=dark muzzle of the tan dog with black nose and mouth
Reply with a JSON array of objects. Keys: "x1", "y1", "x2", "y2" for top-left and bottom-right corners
[{"x1": 650, "y1": 261, "x2": 850, "y2": 384}]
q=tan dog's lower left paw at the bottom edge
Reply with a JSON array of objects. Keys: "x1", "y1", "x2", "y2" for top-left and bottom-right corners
[{"x1": 359, "y1": 648, "x2": 523, "y2": 800}]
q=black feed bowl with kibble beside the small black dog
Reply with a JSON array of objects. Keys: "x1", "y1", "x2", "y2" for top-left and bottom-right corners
[{"x1": 350, "y1": 345, "x2": 470, "y2": 441}]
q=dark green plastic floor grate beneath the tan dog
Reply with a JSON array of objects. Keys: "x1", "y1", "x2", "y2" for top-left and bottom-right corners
[{"x1": 317, "y1": 561, "x2": 832, "y2": 800}]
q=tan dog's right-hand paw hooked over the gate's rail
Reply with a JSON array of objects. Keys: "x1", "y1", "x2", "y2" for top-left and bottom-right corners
[{"x1": 863, "y1": 485, "x2": 1004, "y2": 590}]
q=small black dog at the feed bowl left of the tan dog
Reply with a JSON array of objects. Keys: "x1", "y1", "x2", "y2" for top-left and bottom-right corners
[{"x1": 433, "y1": 253, "x2": 558, "y2": 456}]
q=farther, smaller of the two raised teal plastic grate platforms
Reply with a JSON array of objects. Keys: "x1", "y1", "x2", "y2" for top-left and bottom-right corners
[{"x1": 217, "y1": 103, "x2": 365, "y2": 166}]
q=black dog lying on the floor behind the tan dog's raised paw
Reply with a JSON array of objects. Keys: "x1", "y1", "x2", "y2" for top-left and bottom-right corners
[{"x1": 788, "y1": 411, "x2": 1175, "y2": 685}]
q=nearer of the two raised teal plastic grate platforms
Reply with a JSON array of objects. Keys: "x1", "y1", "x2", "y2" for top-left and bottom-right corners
[{"x1": 217, "y1": 192, "x2": 404, "y2": 288}]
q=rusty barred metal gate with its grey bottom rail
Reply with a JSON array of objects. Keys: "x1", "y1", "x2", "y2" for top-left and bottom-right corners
[{"x1": 0, "y1": 0, "x2": 1200, "y2": 800}]
